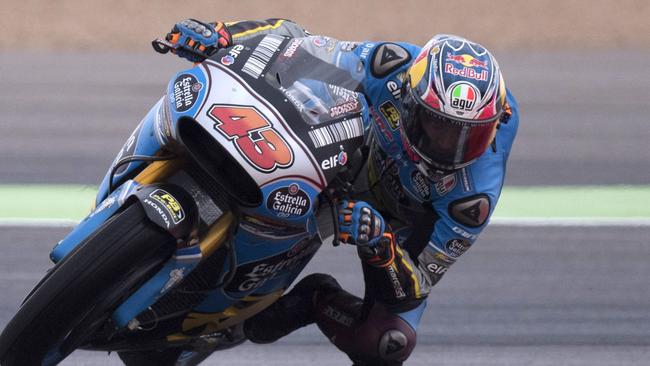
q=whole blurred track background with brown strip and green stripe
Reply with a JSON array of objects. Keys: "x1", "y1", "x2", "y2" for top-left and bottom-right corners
[{"x1": 0, "y1": 0, "x2": 650, "y2": 366}]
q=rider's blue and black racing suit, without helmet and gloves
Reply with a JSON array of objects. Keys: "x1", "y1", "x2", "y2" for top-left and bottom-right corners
[{"x1": 123, "y1": 19, "x2": 519, "y2": 365}]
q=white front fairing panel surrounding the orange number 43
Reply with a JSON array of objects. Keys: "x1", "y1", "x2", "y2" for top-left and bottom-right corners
[{"x1": 195, "y1": 62, "x2": 326, "y2": 189}]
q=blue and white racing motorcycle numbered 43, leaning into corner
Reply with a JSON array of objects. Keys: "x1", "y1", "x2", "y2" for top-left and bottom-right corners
[{"x1": 0, "y1": 35, "x2": 368, "y2": 366}]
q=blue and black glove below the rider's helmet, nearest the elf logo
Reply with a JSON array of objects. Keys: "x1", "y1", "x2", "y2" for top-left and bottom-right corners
[{"x1": 338, "y1": 200, "x2": 386, "y2": 247}]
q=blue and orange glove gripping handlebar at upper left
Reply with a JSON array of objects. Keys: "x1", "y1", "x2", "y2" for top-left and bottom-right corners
[{"x1": 165, "y1": 19, "x2": 232, "y2": 62}]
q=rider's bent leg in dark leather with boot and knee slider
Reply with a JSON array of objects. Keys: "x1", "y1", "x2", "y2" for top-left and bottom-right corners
[{"x1": 244, "y1": 274, "x2": 424, "y2": 366}]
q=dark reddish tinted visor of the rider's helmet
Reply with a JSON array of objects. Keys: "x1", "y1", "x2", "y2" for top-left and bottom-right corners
[{"x1": 402, "y1": 91, "x2": 498, "y2": 170}]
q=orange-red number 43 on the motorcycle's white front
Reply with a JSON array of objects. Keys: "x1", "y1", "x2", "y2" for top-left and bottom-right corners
[{"x1": 208, "y1": 104, "x2": 294, "y2": 173}]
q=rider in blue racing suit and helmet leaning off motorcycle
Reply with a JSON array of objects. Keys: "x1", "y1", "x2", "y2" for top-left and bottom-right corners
[{"x1": 123, "y1": 19, "x2": 519, "y2": 365}]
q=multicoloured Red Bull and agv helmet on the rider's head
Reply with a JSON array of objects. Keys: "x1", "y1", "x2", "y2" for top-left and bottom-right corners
[{"x1": 401, "y1": 35, "x2": 506, "y2": 177}]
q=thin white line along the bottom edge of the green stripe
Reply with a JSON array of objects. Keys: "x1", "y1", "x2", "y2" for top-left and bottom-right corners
[{"x1": 0, "y1": 217, "x2": 650, "y2": 227}]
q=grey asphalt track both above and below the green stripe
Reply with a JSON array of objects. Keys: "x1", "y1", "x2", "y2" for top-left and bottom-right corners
[{"x1": 0, "y1": 52, "x2": 650, "y2": 366}]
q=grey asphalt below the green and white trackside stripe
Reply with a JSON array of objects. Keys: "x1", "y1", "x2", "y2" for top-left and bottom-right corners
[{"x1": 0, "y1": 227, "x2": 650, "y2": 366}]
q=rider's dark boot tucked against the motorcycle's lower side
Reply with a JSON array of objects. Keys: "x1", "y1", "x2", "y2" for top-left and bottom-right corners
[{"x1": 244, "y1": 273, "x2": 341, "y2": 343}]
